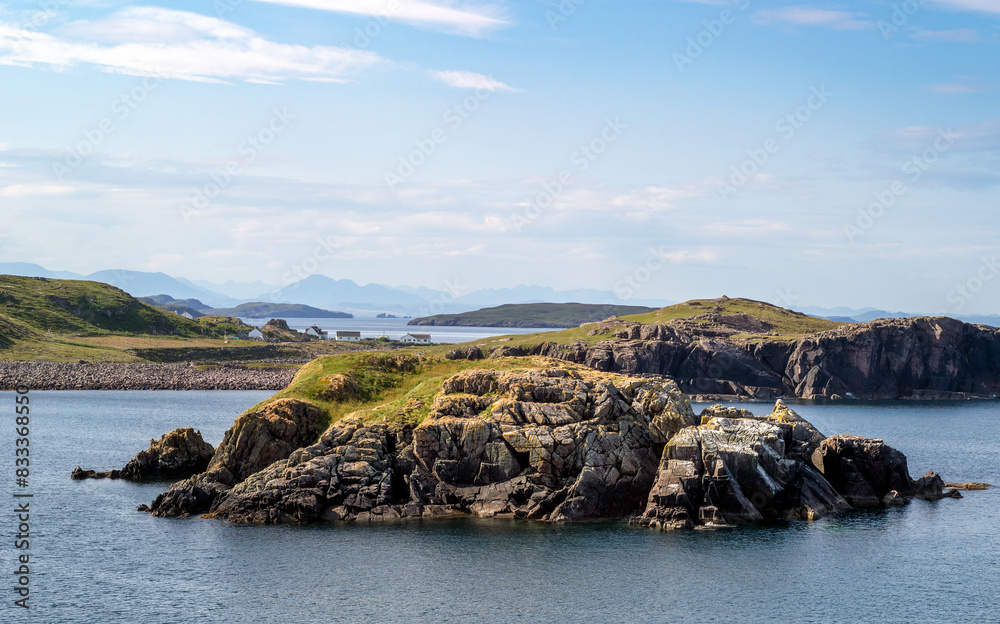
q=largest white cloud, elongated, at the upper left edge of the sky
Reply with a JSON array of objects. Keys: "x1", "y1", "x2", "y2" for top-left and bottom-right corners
[{"x1": 0, "y1": 7, "x2": 381, "y2": 82}]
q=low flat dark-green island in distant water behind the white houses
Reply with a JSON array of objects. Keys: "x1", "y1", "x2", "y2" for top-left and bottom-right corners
[{"x1": 407, "y1": 303, "x2": 654, "y2": 327}]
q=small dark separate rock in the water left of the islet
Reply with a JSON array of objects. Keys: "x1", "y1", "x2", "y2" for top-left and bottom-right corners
[{"x1": 71, "y1": 427, "x2": 215, "y2": 481}]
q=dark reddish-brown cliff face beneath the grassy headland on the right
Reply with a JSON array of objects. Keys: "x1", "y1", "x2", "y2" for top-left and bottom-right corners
[{"x1": 458, "y1": 317, "x2": 1000, "y2": 399}]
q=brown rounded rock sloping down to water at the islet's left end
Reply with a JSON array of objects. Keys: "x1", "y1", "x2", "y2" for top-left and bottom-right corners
[{"x1": 150, "y1": 399, "x2": 326, "y2": 517}]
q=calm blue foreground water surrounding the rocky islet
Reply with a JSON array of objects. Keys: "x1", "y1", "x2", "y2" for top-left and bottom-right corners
[{"x1": 0, "y1": 391, "x2": 1000, "y2": 624}]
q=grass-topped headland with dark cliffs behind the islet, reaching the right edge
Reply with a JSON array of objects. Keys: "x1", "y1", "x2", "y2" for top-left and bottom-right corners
[{"x1": 449, "y1": 297, "x2": 1000, "y2": 399}]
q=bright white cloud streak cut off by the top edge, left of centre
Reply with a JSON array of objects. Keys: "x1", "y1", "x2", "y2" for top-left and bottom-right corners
[{"x1": 246, "y1": 0, "x2": 507, "y2": 36}]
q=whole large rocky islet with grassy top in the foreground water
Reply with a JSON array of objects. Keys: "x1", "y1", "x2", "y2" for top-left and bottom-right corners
[{"x1": 94, "y1": 353, "x2": 959, "y2": 529}]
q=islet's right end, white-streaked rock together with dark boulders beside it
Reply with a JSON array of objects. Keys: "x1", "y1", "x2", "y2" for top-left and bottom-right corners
[{"x1": 631, "y1": 400, "x2": 960, "y2": 529}]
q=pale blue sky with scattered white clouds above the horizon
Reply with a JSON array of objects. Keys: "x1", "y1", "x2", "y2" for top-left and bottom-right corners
[{"x1": 0, "y1": 0, "x2": 1000, "y2": 314}]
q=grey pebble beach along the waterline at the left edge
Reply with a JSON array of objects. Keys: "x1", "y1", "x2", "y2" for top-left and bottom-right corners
[{"x1": 0, "y1": 361, "x2": 298, "y2": 390}]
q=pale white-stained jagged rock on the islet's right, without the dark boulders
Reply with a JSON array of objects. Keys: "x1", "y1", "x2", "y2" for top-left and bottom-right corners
[{"x1": 632, "y1": 401, "x2": 849, "y2": 529}]
